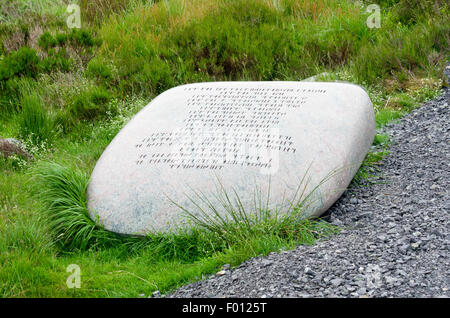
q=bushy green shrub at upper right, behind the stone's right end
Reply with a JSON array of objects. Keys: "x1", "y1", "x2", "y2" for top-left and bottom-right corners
[{"x1": 350, "y1": 13, "x2": 450, "y2": 87}]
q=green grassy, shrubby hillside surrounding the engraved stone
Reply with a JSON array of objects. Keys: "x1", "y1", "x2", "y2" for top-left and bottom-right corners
[{"x1": 0, "y1": 0, "x2": 450, "y2": 297}]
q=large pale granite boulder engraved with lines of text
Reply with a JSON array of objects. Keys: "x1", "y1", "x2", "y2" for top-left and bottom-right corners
[{"x1": 88, "y1": 82, "x2": 375, "y2": 234}]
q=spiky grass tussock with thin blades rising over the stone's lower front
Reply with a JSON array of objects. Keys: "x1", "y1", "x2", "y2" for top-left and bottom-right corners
[{"x1": 172, "y1": 169, "x2": 340, "y2": 251}]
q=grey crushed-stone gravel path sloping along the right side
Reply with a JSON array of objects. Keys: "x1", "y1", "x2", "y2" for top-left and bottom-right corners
[{"x1": 167, "y1": 68, "x2": 450, "y2": 297}]
